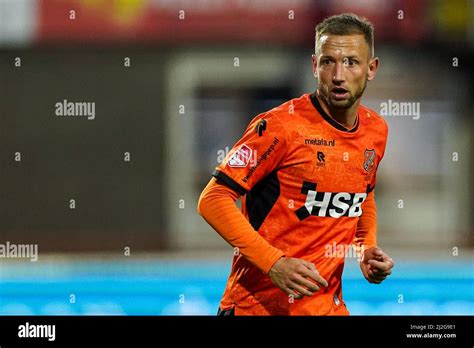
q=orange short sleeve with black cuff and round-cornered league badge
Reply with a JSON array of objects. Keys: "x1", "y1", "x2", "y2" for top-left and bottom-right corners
[{"x1": 213, "y1": 113, "x2": 287, "y2": 195}]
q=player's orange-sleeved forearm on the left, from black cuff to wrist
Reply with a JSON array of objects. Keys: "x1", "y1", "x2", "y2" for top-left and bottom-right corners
[{"x1": 198, "y1": 178, "x2": 283, "y2": 273}]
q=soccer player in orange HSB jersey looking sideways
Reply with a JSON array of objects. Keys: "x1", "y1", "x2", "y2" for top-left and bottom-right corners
[{"x1": 198, "y1": 14, "x2": 394, "y2": 315}]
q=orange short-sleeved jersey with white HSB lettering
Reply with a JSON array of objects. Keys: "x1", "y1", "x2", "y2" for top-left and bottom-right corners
[{"x1": 213, "y1": 94, "x2": 388, "y2": 315}]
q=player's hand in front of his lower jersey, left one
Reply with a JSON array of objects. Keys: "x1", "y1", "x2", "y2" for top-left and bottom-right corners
[{"x1": 268, "y1": 257, "x2": 328, "y2": 299}]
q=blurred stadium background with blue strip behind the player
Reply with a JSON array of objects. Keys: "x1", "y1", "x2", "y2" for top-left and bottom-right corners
[{"x1": 0, "y1": 0, "x2": 474, "y2": 315}]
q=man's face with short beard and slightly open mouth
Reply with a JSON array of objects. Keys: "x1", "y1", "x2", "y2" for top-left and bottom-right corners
[{"x1": 313, "y1": 34, "x2": 378, "y2": 109}]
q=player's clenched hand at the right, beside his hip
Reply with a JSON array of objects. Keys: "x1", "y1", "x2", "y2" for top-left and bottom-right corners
[{"x1": 360, "y1": 247, "x2": 395, "y2": 284}]
